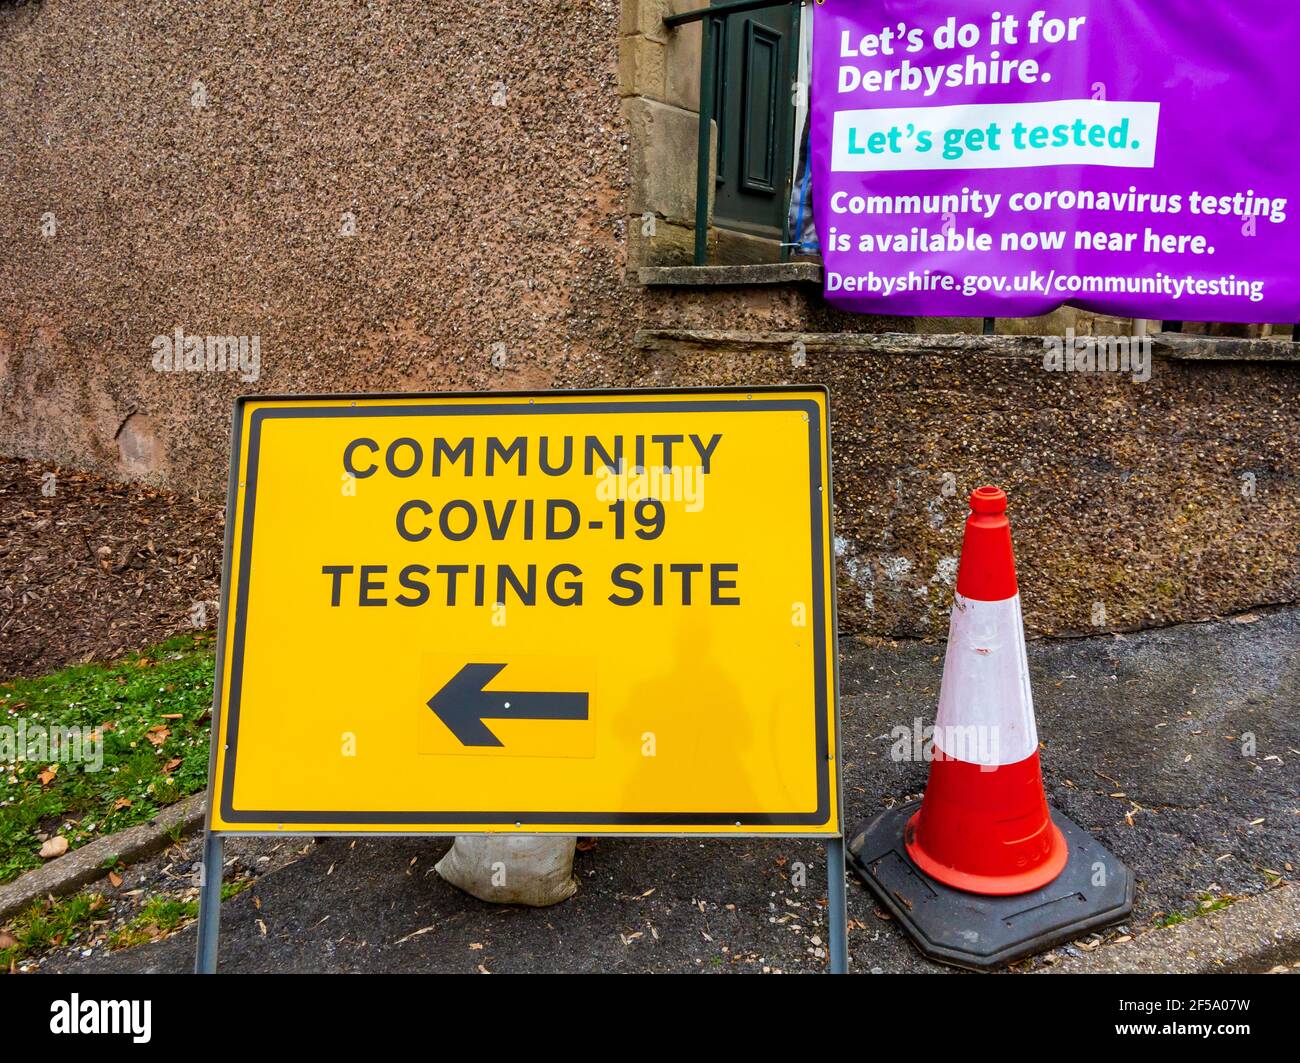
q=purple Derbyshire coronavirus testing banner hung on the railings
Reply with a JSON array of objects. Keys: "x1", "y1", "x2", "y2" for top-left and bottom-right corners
[{"x1": 811, "y1": 0, "x2": 1300, "y2": 322}]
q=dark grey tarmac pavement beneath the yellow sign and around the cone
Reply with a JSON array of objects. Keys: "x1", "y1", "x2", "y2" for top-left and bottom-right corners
[{"x1": 42, "y1": 608, "x2": 1300, "y2": 972}]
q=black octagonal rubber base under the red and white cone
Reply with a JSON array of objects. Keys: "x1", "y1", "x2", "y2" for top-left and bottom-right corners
[{"x1": 848, "y1": 800, "x2": 1134, "y2": 971}]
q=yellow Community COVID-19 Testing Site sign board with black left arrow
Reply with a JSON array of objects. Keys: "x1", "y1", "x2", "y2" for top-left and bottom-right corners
[{"x1": 209, "y1": 389, "x2": 840, "y2": 834}]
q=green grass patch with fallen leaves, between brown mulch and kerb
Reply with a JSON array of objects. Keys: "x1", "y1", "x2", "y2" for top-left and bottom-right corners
[{"x1": 0, "y1": 633, "x2": 215, "y2": 882}]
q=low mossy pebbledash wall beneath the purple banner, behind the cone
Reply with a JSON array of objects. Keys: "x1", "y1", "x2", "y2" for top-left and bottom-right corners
[{"x1": 637, "y1": 331, "x2": 1300, "y2": 635}]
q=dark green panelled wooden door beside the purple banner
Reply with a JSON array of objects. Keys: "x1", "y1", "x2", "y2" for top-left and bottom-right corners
[{"x1": 710, "y1": 4, "x2": 798, "y2": 240}]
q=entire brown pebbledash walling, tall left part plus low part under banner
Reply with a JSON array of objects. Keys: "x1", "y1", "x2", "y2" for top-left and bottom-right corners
[{"x1": 0, "y1": 0, "x2": 1300, "y2": 635}]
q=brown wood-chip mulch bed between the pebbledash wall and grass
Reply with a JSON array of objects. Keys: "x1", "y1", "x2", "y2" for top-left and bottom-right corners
[{"x1": 0, "y1": 457, "x2": 225, "y2": 678}]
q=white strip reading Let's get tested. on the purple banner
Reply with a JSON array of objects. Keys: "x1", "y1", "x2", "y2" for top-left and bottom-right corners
[{"x1": 831, "y1": 100, "x2": 1160, "y2": 173}]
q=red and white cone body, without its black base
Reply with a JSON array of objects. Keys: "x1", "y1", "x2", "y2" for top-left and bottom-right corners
[{"x1": 906, "y1": 487, "x2": 1069, "y2": 894}]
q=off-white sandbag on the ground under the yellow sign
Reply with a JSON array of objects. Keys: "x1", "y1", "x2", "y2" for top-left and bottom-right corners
[{"x1": 436, "y1": 834, "x2": 577, "y2": 908}]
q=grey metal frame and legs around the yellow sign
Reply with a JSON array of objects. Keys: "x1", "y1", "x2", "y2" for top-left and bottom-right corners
[{"x1": 195, "y1": 385, "x2": 848, "y2": 973}]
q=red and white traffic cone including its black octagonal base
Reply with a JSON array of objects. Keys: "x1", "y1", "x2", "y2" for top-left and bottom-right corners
[{"x1": 849, "y1": 487, "x2": 1134, "y2": 968}]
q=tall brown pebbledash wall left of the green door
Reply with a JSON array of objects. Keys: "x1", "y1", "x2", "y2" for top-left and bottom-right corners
[{"x1": 0, "y1": 0, "x2": 879, "y2": 493}]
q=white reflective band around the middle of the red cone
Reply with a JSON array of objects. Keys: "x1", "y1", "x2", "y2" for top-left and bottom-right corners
[{"x1": 935, "y1": 594, "x2": 1039, "y2": 767}]
